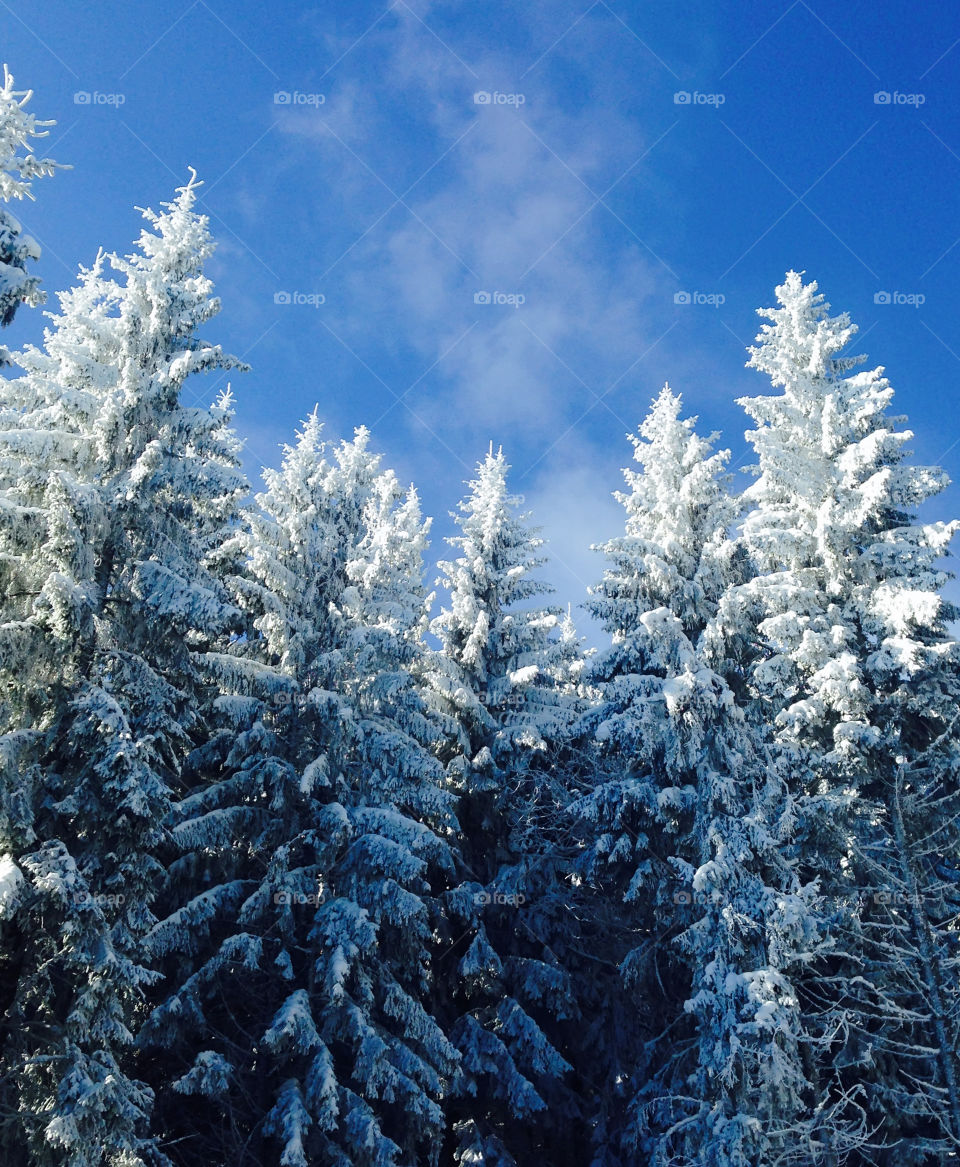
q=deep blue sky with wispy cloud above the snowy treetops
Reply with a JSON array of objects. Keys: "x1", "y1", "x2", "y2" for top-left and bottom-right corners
[{"x1": 0, "y1": 0, "x2": 960, "y2": 634}]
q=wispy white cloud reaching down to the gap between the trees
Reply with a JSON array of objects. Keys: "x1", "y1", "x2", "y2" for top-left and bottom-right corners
[{"x1": 258, "y1": 5, "x2": 675, "y2": 638}]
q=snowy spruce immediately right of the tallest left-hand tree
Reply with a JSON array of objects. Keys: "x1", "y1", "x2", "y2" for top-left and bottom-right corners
[{"x1": 141, "y1": 413, "x2": 363, "y2": 1163}]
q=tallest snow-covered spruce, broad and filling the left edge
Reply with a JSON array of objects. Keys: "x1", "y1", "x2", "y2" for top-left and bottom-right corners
[{"x1": 0, "y1": 172, "x2": 245, "y2": 1167}]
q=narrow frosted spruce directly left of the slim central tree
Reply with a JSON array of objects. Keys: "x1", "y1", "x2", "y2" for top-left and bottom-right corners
[{"x1": 317, "y1": 450, "x2": 458, "y2": 1167}]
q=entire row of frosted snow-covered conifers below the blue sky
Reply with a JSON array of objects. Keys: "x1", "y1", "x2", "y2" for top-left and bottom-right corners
[{"x1": 0, "y1": 66, "x2": 960, "y2": 1167}]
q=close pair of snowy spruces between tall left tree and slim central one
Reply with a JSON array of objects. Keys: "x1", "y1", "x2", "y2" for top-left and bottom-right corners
[{"x1": 145, "y1": 414, "x2": 466, "y2": 1167}]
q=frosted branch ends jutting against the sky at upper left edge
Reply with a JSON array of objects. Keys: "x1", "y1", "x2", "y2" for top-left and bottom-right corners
[{"x1": 0, "y1": 65, "x2": 57, "y2": 354}]
